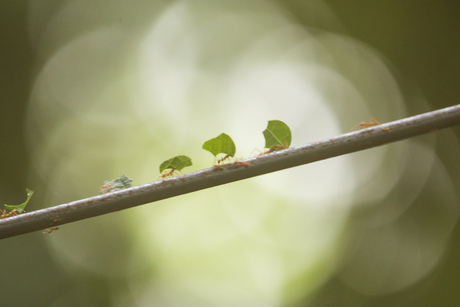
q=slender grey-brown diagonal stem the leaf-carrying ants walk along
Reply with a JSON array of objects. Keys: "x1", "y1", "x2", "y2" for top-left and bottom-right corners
[{"x1": 0, "y1": 105, "x2": 460, "y2": 239}]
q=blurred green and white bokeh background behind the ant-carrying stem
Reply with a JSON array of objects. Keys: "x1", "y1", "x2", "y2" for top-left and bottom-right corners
[{"x1": 0, "y1": 0, "x2": 460, "y2": 306}]
